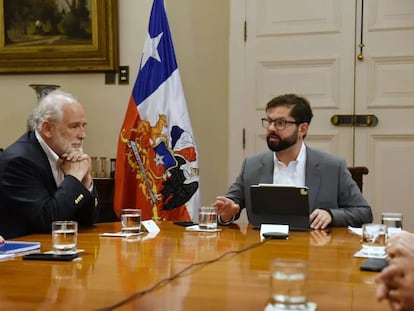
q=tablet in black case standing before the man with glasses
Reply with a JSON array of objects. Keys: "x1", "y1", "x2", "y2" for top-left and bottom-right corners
[{"x1": 247, "y1": 184, "x2": 310, "y2": 231}]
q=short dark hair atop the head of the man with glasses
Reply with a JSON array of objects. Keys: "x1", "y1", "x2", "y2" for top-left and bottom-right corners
[{"x1": 266, "y1": 94, "x2": 313, "y2": 124}]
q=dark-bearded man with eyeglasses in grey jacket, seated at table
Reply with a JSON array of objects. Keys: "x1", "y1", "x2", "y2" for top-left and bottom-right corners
[{"x1": 213, "y1": 94, "x2": 372, "y2": 229}]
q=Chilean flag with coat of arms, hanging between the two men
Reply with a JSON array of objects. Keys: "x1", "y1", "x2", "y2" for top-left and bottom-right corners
[{"x1": 114, "y1": 0, "x2": 200, "y2": 222}]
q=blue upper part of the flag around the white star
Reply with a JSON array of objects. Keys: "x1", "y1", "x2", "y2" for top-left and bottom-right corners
[{"x1": 133, "y1": 0, "x2": 177, "y2": 105}]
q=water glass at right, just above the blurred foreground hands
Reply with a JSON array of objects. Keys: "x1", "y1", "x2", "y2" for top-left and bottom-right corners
[{"x1": 361, "y1": 224, "x2": 387, "y2": 256}]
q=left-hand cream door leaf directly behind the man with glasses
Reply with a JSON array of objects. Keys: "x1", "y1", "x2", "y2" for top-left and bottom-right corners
[{"x1": 245, "y1": 0, "x2": 355, "y2": 161}]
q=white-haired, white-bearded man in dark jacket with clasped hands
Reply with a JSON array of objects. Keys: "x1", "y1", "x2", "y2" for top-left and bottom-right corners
[{"x1": 0, "y1": 91, "x2": 100, "y2": 239}]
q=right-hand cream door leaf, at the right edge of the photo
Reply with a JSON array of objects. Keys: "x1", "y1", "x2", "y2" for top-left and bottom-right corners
[{"x1": 355, "y1": 0, "x2": 414, "y2": 230}]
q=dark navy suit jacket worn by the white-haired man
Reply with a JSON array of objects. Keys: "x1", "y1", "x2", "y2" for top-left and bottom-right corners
[{"x1": 0, "y1": 132, "x2": 100, "y2": 239}]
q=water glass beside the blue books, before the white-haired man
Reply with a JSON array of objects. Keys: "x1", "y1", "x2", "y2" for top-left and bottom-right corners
[{"x1": 52, "y1": 221, "x2": 78, "y2": 255}]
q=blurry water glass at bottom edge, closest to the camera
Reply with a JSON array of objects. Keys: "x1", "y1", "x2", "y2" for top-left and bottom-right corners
[{"x1": 270, "y1": 258, "x2": 308, "y2": 310}]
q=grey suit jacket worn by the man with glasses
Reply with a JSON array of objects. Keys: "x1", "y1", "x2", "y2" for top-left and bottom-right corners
[{"x1": 225, "y1": 146, "x2": 372, "y2": 227}]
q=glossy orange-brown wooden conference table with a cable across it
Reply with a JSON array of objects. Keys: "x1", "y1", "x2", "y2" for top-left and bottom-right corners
[{"x1": 0, "y1": 222, "x2": 388, "y2": 311}]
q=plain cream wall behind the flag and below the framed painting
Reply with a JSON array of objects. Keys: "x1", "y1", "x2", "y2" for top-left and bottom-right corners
[{"x1": 0, "y1": 0, "x2": 229, "y2": 204}]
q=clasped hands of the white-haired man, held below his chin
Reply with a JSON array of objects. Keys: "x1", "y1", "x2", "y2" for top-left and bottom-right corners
[{"x1": 60, "y1": 149, "x2": 92, "y2": 188}]
